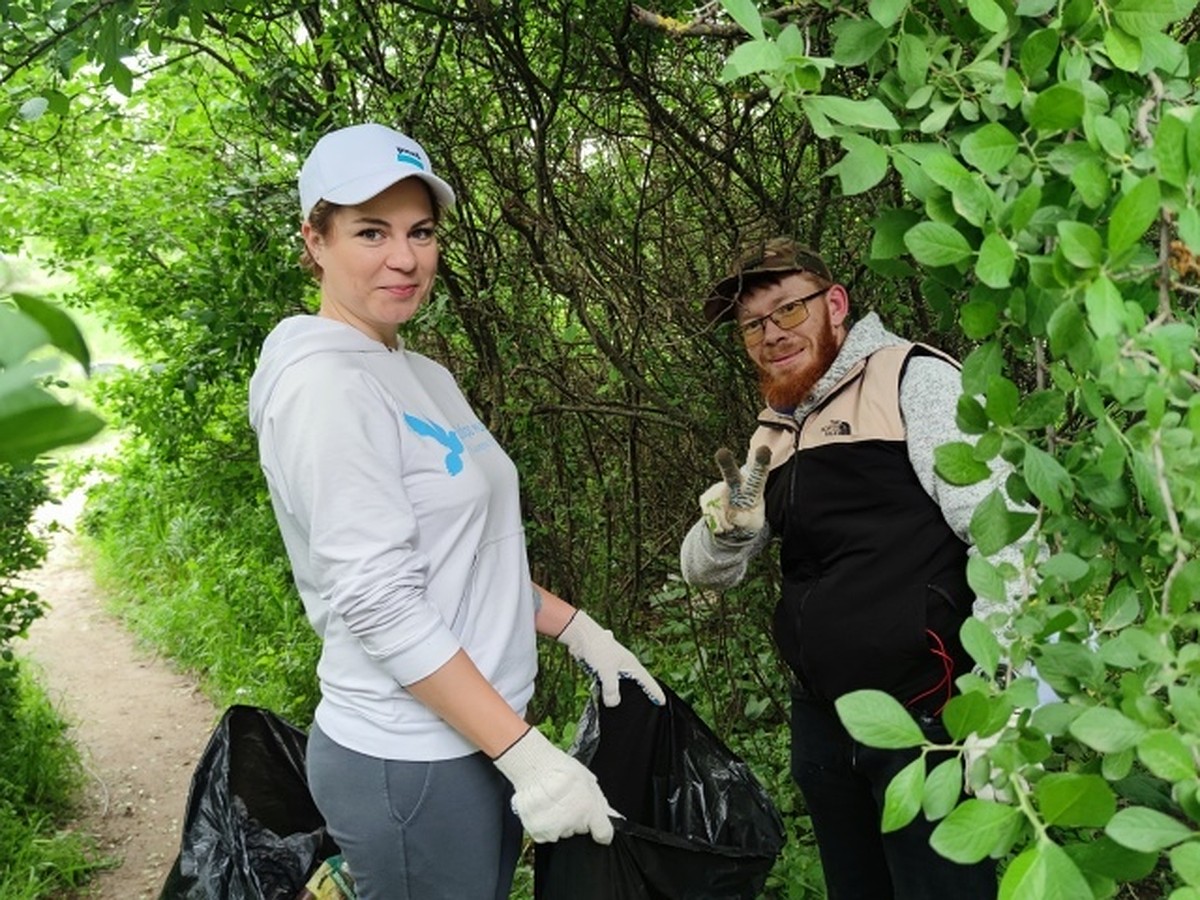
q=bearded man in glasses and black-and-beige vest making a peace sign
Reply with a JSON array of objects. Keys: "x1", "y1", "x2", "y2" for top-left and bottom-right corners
[{"x1": 680, "y1": 239, "x2": 1012, "y2": 900}]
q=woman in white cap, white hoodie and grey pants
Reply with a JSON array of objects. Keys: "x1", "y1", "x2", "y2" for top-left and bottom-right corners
[{"x1": 250, "y1": 125, "x2": 661, "y2": 900}]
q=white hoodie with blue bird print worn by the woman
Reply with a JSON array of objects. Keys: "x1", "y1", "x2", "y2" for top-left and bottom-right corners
[{"x1": 250, "y1": 316, "x2": 538, "y2": 761}]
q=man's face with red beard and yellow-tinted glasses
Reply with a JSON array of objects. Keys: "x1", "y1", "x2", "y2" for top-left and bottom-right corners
[{"x1": 737, "y1": 272, "x2": 850, "y2": 409}]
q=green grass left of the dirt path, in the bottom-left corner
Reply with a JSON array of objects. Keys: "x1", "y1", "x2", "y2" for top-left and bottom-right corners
[{"x1": 0, "y1": 662, "x2": 110, "y2": 900}]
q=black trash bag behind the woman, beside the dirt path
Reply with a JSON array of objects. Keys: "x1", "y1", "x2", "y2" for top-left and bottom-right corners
[{"x1": 158, "y1": 706, "x2": 338, "y2": 900}]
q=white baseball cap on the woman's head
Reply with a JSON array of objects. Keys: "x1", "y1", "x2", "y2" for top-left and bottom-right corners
[{"x1": 300, "y1": 124, "x2": 455, "y2": 218}]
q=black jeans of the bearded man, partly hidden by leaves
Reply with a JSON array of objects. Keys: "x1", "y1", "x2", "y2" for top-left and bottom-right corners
[{"x1": 792, "y1": 694, "x2": 996, "y2": 900}]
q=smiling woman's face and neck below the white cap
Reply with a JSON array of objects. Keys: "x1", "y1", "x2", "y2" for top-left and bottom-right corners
[{"x1": 302, "y1": 178, "x2": 438, "y2": 347}]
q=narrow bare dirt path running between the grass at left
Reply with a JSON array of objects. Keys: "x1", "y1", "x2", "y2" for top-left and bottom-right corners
[{"x1": 20, "y1": 496, "x2": 217, "y2": 900}]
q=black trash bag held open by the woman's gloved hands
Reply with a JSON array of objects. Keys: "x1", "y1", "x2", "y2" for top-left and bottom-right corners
[{"x1": 534, "y1": 680, "x2": 785, "y2": 900}]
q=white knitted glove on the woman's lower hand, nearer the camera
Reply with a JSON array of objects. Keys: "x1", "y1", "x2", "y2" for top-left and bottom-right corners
[{"x1": 492, "y1": 727, "x2": 616, "y2": 844}]
